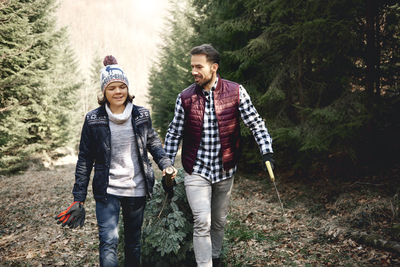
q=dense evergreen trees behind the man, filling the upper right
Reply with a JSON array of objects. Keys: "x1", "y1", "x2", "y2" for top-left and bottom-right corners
[{"x1": 149, "y1": 0, "x2": 400, "y2": 177}]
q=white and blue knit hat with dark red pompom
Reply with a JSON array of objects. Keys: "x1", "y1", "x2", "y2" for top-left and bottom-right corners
[{"x1": 100, "y1": 55, "x2": 129, "y2": 92}]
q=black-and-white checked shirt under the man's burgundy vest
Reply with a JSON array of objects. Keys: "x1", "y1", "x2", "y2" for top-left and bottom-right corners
[{"x1": 164, "y1": 79, "x2": 273, "y2": 183}]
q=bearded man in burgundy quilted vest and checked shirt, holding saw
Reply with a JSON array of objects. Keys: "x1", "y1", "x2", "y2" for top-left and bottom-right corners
[{"x1": 164, "y1": 44, "x2": 273, "y2": 266}]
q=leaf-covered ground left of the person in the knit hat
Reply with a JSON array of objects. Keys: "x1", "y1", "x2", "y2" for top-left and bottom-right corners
[{"x1": 0, "y1": 165, "x2": 98, "y2": 266}]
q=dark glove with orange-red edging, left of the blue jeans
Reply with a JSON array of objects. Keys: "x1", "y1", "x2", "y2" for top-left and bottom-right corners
[{"x1": 55, "y1": 201, "x2": 86, "y2": 228}]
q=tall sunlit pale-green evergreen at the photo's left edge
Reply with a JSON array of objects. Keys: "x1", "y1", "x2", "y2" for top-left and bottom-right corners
[{"x1": 0, "y1": 0, "x2": 79, "y2": 173}]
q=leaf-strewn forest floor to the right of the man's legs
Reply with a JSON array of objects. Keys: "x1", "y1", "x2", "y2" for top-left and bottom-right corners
[{"x1": 225, "y1": 166, "x2": 400, "y2": 266}]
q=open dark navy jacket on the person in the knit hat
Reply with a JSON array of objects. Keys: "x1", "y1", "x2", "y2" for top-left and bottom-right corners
[{"x1": 72, "y1": 105, "x2": 172, "y2": 201}]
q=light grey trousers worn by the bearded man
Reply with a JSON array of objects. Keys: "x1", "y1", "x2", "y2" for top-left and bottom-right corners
[{"x1": 185, "y1": 173, "x2": 233, "y2": 267}]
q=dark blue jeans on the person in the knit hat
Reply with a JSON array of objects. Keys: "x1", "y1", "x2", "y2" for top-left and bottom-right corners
[{"x1": 96, "y1": 194, "x2": 146, "y2": 267}]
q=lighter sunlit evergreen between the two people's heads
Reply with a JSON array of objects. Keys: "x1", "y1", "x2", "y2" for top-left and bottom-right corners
[{"x1": 149, "y1": 1, "x2": 194, "y2": 137}]
